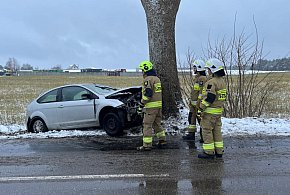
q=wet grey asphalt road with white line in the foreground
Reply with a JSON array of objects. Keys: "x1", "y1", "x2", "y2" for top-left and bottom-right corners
[{"x1": 0, "y1": 136, "x2": 290, "y2": 195}]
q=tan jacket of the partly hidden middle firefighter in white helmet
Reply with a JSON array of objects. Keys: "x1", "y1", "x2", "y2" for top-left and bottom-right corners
[{"x1": 190, "y1": 75, "x2": 207, "y2": 106}]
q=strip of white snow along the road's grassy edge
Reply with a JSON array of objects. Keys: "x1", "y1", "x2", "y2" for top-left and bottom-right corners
[{"x1": 0, "y1": 108, "x2": 290, "y2": 139}]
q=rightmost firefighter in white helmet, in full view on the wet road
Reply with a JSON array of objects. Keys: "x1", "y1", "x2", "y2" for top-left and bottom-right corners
[{"x1": 198, "y1": 58, "x2": 227, "y2": 158}]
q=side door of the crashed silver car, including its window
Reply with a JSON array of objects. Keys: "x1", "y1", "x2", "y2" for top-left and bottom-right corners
[{"x1": 58, "y1": 86, "x2": 96, "y2": 129}]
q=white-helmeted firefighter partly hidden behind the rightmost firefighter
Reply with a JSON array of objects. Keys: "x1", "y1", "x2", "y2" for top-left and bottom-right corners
[{"x1": 182, "y1": 60, "x2": 207, "y2": 142}]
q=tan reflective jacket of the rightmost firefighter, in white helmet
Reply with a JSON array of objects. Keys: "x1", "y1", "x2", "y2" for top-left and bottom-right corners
[{"x1": 200, "y1": 77, "x2": 227, "y2": 115}]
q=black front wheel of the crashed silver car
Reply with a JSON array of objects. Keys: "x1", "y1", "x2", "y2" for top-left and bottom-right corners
[{"x1": 103, "y1": 113, "x2": 123, "y2": 136}]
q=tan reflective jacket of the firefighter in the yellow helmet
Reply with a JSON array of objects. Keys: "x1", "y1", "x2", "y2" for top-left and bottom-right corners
[{"x1": 141, "y1": 76, "x2": 162, "y2": 108}]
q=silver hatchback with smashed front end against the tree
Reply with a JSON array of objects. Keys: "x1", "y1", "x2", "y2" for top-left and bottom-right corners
[{"x1": 26, "y1": 84, "x2": 142, "y2": 136}]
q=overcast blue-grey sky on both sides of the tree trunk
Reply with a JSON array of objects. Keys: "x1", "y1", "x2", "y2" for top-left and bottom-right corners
[{"x1": 0, "y1": 0, "x2": 290, "y2": 69}]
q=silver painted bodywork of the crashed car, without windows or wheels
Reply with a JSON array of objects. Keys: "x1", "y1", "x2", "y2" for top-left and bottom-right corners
[{"x1": 26, "y1": 84, "x2": 140, "y2": 133}]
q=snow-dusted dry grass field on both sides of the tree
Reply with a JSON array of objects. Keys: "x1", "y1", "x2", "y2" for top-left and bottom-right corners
[{"x1": 0, "y1": 73, "x2": 290, "y2": 125}]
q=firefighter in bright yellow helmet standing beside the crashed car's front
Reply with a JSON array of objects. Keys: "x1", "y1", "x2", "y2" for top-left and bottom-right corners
[{"x1": 137, "y1": 61, "x2": 166, "y2": 151}]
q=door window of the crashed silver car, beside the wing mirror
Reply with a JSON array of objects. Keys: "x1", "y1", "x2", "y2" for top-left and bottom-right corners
[{"x1": 62, "y1": 86, "x2": 91, "y2": 101}]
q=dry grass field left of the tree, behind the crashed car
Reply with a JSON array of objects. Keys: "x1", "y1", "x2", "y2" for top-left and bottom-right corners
[{"x1": 0, "y1": 76, "x2": 142, "y2": 125}]
